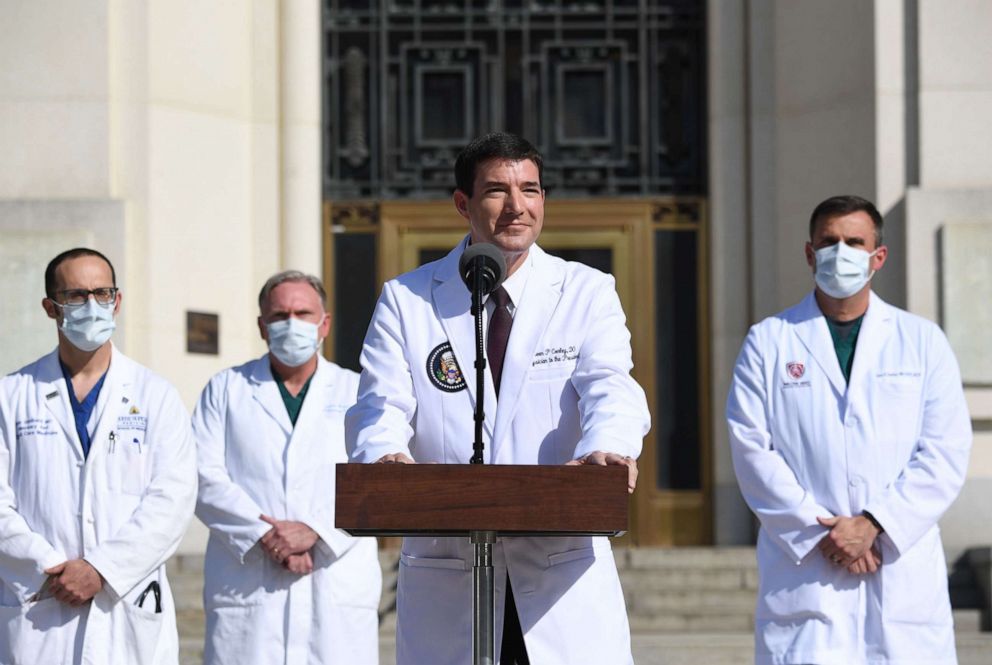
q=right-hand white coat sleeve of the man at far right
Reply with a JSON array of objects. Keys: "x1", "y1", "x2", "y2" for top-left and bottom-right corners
[{"x1": 865, "y1": 326, "x2": 972, "y2": 553}]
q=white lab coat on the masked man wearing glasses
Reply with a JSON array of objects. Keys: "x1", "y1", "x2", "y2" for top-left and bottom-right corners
[{"x1": 0, "y1": 348, "x2": 196, "y2": 665}]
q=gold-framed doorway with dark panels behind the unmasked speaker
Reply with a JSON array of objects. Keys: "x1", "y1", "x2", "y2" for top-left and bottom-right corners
[{"x1": 324, "y1": 197, "x2": 713, "y2": 546}]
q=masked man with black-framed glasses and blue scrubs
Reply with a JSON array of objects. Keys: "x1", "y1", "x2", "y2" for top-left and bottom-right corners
[{"x1": 0, "y1": 248, "x2": 196, "y2": 665}]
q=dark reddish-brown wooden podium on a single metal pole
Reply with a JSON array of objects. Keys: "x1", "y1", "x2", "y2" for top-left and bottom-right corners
[{"x1": 334, "y1": 464, "x2": 628, "y2": 665}]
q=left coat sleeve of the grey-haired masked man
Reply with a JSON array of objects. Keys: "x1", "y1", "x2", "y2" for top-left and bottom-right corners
[{"x1": 193, "y1": 371, "x2": 272, "y2": 563}]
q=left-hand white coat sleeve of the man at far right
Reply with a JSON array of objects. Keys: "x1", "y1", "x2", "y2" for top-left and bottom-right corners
[{"x1": 727, "y1": 328, "x2": 833, "y2": 565}]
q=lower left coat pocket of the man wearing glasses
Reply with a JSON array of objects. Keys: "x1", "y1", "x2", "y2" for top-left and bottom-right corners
[{"x1": 0, "y1": 598, "x2": 69, "y2": 665}]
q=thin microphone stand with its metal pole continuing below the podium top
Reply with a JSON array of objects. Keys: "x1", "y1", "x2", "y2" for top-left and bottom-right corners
[{"x1": 469, "y1": 256, "x2": 496, "y2": 665}]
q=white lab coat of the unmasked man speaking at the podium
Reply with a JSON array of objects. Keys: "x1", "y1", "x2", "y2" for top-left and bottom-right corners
[{"x1": 347, "y1": 242, "x2": 650, "y2": 665}]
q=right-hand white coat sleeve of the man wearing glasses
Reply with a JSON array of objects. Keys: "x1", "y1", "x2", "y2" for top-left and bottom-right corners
[{"x1": 85, "y1": 386, "x2": 196, "y2": 599}]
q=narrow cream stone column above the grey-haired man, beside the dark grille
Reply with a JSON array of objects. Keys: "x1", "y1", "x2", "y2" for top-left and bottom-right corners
[{"x1": 279, "y1": 0, "x2": 322, "y2": 275}]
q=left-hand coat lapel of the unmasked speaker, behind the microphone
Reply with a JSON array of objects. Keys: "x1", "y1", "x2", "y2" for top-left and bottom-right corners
[{"x1": 434, "y1": 241, "x2": 496, "y2": 448}]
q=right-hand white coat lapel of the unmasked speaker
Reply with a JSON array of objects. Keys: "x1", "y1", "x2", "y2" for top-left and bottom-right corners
[{"x1": 493, "y1": 245, "x2": 564, "y2": 459}]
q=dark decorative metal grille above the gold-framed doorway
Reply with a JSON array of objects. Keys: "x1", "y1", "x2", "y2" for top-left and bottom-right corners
[{"x1": 324, "y1": 0, "x2": 705, "y2": 199}]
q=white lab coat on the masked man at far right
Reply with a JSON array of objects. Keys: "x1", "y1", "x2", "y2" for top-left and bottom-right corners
[{"x1": 727, "y1": 293, "x2": 971, "y2": 665}]
